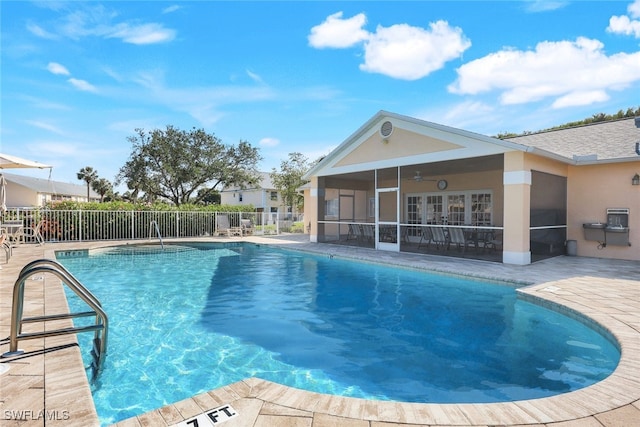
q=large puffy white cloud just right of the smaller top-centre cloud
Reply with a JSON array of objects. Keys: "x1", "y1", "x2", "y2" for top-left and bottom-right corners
[{"x1": 360, "y1": 21, "x2": 471, "y2": 80}]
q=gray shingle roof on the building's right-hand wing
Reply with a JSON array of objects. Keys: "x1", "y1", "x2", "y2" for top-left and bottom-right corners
[{"x1": 506, "y1": 117, "x2": 640, "y2": 162}]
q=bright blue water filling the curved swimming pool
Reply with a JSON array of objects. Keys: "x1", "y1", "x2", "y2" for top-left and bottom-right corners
[{"x1": 58, "y1": 243, "x2": 620, "y2": 424}]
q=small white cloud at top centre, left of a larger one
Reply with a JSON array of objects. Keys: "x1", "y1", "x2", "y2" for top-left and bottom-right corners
[{"x1": 308, "y1": 12, "x2": 369, "y2": 49}]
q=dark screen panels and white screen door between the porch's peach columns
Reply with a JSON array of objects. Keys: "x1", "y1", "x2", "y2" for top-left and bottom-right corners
[{"x1": 318, "y1": 155, "x2": 566, "y2": 262}]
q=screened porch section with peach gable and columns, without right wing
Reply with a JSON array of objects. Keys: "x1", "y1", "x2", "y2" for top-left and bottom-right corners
[{"x1": 305, "y1": 112, "x2": 567, "y2": 264}]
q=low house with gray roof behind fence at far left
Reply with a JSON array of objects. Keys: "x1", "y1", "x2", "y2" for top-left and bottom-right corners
[{"x1": 2, "y1": 172, "x2": 100, "y2": 208}]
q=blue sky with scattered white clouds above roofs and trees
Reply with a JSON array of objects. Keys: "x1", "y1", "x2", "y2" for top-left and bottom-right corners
[{"x1": 0, "y1": 0, "x2": 640, "y2": 189}]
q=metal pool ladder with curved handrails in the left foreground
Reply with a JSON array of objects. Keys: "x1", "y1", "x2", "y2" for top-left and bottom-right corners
[{"x1": 0, "y1": 259, "x2": 109, "y2": 381}]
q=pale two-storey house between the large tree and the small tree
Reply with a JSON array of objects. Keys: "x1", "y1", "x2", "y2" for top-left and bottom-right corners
[{"x1": 220, "y1": 172, "x2": 291, "y2": 216}]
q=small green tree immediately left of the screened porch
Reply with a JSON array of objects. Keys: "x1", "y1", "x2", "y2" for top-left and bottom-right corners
[{"x1": 269, "y1": 153, "x2": 310, "y2": 214}]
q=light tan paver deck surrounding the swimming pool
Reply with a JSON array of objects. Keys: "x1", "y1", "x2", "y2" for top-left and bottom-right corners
[{"x1": 0, "y1": 236, "x2": 640, "y2": 427}]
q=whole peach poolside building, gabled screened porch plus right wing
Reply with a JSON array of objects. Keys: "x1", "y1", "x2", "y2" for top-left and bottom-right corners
[{"x1": 304, "y1": 111, "x2": 640, "y2": 265}]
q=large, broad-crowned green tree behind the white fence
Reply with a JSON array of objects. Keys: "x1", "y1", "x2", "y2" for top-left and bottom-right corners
[{"x1": 116, "y1": 126, "x2": 261, "y2": 206}]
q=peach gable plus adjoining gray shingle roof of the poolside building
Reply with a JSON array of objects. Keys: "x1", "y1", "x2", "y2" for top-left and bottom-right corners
[{"x1": 304, "y1": 111, "x2": 640, "y2": 179}]
